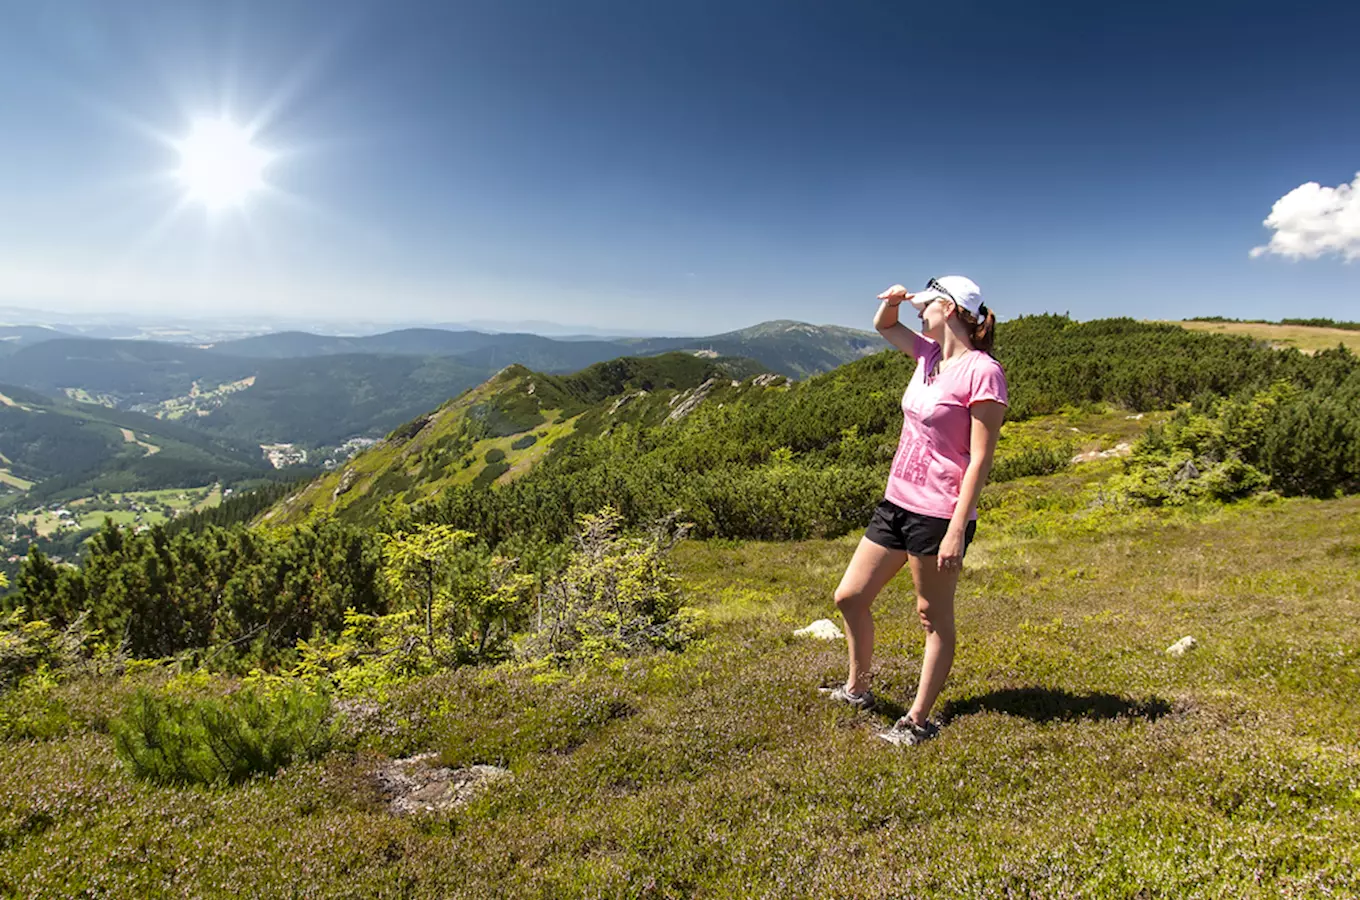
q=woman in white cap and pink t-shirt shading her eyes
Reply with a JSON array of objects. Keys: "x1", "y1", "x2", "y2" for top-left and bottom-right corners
[{"x1": 827, "y1": 275, "x2": 1006, "y2": 744}]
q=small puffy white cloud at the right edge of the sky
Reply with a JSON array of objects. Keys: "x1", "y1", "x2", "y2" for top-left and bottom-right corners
[{"x1": 1251, "y1": 173, "x2": 1360, "y2": 261}]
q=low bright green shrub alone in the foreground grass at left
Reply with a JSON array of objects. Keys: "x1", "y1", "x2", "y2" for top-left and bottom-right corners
[{"x1": 110, "y1": 687, "x2": 335, "y2": 784}]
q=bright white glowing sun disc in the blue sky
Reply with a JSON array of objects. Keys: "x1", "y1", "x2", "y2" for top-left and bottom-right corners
[{"x1": 175, "y1": 118, "x2": 271, "y2": 209}]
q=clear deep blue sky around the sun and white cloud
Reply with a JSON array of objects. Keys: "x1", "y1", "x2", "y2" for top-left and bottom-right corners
[{"x1": 0, "y1": 0, "x2": 1360, "y2": 333}]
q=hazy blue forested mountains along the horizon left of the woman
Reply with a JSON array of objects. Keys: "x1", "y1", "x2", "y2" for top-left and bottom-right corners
[{"x1": 0, "y1": 321, "x2": 885, "y2": 447}]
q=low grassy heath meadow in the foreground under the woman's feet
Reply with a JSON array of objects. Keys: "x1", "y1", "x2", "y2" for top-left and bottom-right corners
[{"x1": 0, "y1": 460, "x2": 1360, "y2": 899}]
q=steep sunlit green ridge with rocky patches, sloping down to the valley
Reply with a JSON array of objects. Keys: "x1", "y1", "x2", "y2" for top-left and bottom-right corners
[{"x1": 265, "y1": 353, "x2": 763, "y2": 523}]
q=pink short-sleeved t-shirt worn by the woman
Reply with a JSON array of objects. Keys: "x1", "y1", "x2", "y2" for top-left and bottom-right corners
[{"x1": 884, "y1": 334, "x2": 1006, "y2": 519}]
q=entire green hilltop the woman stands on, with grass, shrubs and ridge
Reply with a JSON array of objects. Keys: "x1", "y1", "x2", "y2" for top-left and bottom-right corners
[{"x1": 0, "y1": 317, "x2": 1360, "y2": 900}]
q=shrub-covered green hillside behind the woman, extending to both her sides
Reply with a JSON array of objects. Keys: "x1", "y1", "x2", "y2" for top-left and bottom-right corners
[{"x1": 269, "y1": 315, "x2": 1360, "y2": 544}]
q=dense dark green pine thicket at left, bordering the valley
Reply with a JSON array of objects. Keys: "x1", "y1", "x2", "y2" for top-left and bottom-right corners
[{"x1": 15, "y1": 522, "x2": 386, "y2": 668}]
